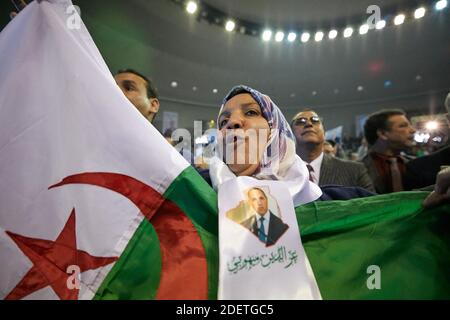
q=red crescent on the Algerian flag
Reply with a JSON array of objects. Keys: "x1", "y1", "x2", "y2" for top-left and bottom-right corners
[{"x1": 49, "y1": 172, "x2": 208, "y2": 300}]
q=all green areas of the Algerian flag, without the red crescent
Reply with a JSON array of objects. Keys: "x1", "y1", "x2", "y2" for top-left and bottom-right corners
[{"x1": 95, "y1": 167, "x2": 450, "y2": 299}]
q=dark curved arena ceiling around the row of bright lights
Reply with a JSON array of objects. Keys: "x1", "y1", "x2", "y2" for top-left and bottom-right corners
[{"x1": 2, "y1": 0, "x2": 450, "y2": 108}]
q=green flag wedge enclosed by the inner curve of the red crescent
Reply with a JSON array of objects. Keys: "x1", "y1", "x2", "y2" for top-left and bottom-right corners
[{"x1": 94, "y1": 219, "x2": 161, "y2": 300}]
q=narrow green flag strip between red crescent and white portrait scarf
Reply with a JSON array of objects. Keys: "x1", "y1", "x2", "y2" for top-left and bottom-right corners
[{"x1": 164, "y1": 167, "x2": 219, "y2": 299}]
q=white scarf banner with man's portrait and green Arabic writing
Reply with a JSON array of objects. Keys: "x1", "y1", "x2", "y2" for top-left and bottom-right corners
[{"x1": 218, "y1": 177, "x2": 321, "y2": 300}]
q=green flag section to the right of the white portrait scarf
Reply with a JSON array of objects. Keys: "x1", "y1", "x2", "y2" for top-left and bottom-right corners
[{"x1": 296, "y1": 192, "x2": 450, "y2": 299}]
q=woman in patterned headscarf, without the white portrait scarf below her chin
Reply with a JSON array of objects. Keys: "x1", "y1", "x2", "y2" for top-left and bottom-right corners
[{"x1": 200, "y1": 85, "x2": 373, "y2": 201}]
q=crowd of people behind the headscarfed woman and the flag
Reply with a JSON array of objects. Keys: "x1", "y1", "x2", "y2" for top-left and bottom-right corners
[{"x1": 7, "y1": 4, "x2": 450, "y2": 208}]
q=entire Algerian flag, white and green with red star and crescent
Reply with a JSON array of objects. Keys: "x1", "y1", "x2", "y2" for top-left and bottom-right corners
[{"x1": 0, "y1": 0, "x2": 450, "y2": 299}]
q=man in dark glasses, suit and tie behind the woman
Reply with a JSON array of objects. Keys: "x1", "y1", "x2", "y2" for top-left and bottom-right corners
[{"x1": 291, "y1": 110, "x2": 374, "y2": 191}]
